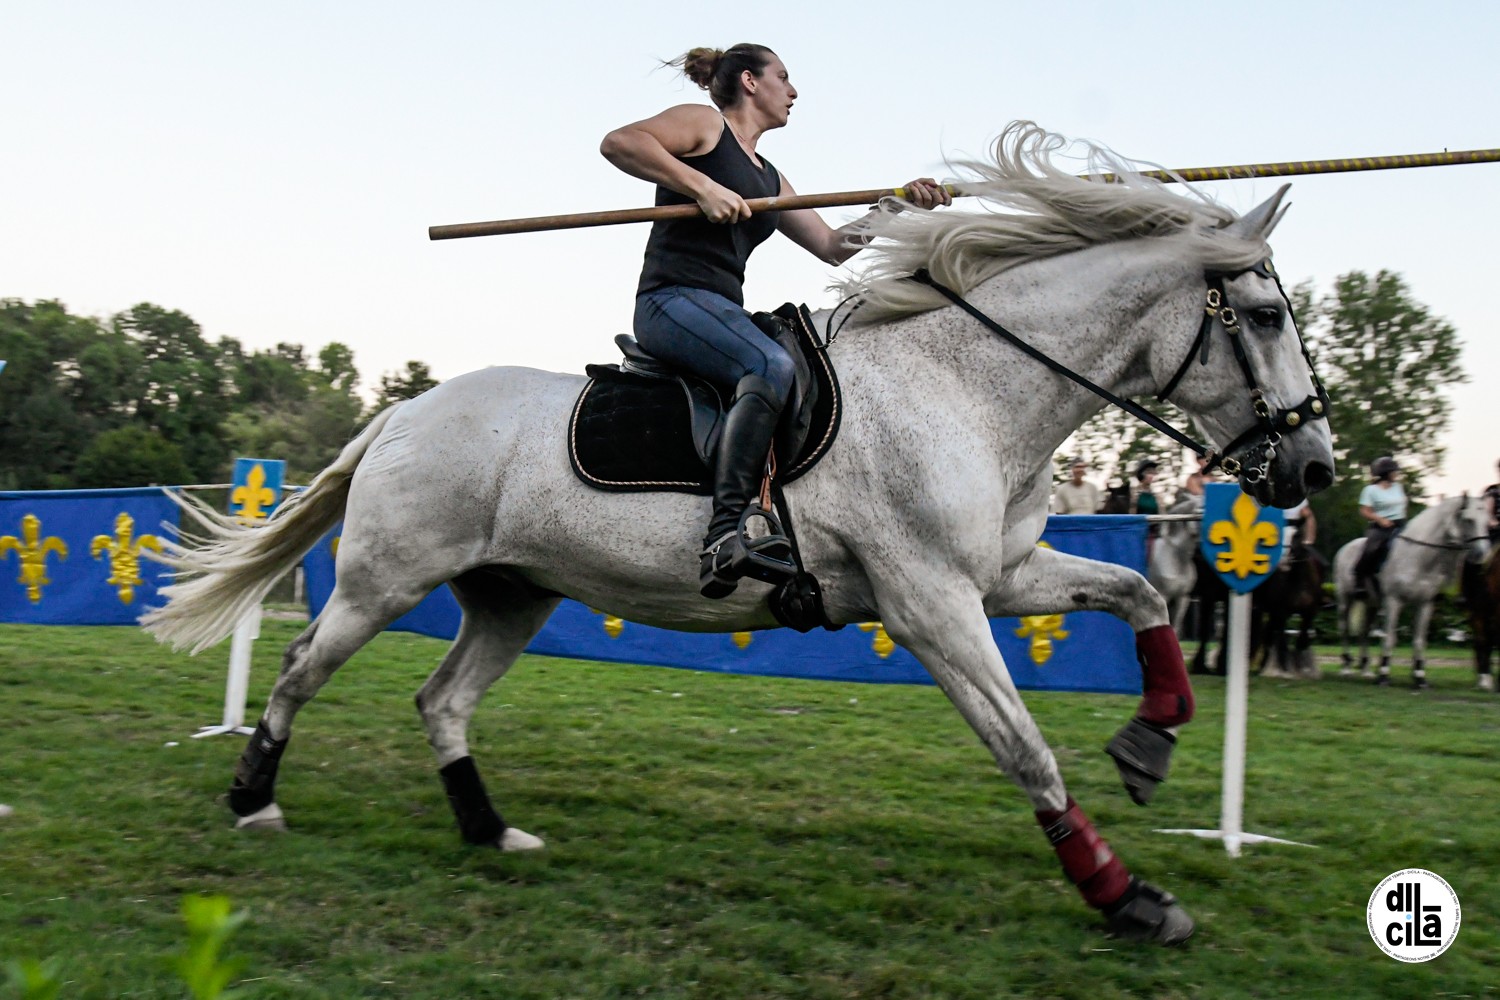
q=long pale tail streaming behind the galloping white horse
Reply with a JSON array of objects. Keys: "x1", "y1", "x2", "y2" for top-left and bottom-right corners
[{"x1": 141, "y1": 403, "x2": 401, "y2": 654}]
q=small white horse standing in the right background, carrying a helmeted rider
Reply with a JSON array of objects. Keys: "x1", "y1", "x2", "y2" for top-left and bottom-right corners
[{"x1": 1334, "y1": 495, "x2": 1490, "y2": 688}]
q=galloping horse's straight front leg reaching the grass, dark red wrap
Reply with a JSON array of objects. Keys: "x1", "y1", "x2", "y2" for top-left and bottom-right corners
[{"x1": 876, "y1": 573, "x2": 1193, "y2": 945}]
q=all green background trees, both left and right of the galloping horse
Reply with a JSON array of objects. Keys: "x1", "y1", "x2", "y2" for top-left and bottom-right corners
[{"x1": 0, "y1": 271, "x2": 1467, "y2": 554}]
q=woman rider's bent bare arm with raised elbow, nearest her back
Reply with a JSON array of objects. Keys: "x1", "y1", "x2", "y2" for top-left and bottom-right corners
[{"x1": 599, "y1": 105, "x2": 750, "y2": 222}]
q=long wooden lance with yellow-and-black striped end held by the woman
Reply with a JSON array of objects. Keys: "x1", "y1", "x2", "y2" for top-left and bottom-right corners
[{"x1": 428, "y1": 148, "x2": 1500, "y2": 240}]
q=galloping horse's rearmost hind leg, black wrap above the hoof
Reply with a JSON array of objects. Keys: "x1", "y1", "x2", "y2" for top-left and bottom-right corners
[{"x1": 230, "y1": 583, "x2": 425, "y2": 829}]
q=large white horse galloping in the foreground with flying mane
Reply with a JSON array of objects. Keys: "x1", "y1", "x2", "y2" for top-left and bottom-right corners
[{"x1": 146, "y1": 123, "x2": 1334, "y2": 943}]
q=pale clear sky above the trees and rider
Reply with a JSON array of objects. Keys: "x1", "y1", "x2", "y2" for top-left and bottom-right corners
[{"x1": 0, "y1": 0, "x2": 1500, "y2": 493}]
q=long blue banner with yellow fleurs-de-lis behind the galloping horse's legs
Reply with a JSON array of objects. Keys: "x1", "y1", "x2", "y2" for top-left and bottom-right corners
[{"x1": 303, "y1": 516, "x2": 1146, "y2": 694}]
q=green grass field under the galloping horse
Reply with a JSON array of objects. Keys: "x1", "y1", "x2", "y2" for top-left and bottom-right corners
[{"x1": 0, "y1": 622, "x2": 1500, "y2": 1000}]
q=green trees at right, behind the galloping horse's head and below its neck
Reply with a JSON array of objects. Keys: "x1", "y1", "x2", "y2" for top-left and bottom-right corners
[{"x1": 1056, "y1": 270, "x2": 1469, "y2": 552}]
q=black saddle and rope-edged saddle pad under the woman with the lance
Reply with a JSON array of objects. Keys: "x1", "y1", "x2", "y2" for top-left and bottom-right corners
[{"x1": 569, "y1": 303, "x2": 842, "y2": 496}]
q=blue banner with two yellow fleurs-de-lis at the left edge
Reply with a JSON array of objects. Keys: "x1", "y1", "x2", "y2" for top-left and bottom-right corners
[{"x1": 0, "y1": 487, "x2": 177, "y2": 625}]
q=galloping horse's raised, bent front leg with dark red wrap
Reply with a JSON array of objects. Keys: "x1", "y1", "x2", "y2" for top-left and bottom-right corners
[{"x1": 986, "y1": 547, "x2": 1194, "y2": 805}]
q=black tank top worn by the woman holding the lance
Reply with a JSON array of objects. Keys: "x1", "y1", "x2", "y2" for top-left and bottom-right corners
[{"x1": 636, "y1": 121, "x2": 782, "y2": 306}]
